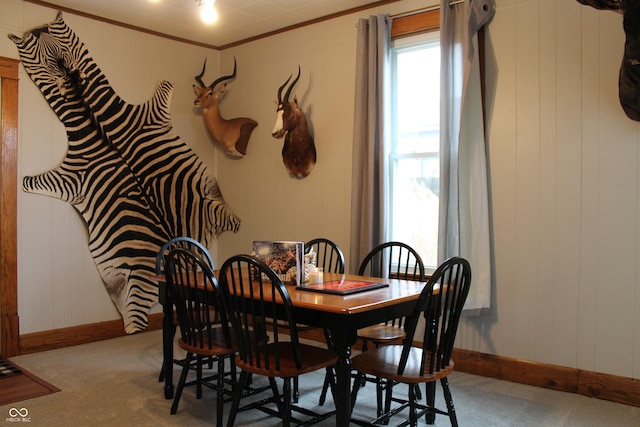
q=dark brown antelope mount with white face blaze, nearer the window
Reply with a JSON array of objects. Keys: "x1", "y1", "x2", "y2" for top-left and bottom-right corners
[{"x1": 271, "y1": 66, "x2": 316, "y2": 178}]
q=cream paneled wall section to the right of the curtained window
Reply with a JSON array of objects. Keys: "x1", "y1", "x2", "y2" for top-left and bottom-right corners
[{"x1": 457, "y1": 0, "x2": 640, "y2": 378}]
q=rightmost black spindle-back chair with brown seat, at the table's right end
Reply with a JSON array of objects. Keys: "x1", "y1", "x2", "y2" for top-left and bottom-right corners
[{"x1": 351, "y1": 257, "x2": 471, "y2": 427}]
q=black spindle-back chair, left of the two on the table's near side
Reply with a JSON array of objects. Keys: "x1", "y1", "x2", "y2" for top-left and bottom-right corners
[{"x1": 164, "y1": 248, "x2": 236, "y2": 426}]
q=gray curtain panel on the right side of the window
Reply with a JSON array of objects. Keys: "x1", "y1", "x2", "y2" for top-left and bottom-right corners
[{"x1": 438, "y1": 0, "x2": 495, "y2": 314}]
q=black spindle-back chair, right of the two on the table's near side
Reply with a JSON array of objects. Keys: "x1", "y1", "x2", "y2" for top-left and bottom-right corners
[{"x1": 220, "y1": 255, "x2": 337, "y2": 426}]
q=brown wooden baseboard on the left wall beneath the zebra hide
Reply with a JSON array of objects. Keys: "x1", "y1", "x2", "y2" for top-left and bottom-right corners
[{"x1": 20, "y1": 313, "x2": 162, "y2": 354}]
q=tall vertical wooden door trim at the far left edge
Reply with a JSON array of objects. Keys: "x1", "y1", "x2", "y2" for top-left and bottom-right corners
[{"x1": 0, "y1": 57, "x2": 20, "y2": 358}]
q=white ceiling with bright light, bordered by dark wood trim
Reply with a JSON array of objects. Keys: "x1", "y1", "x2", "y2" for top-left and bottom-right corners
[{"x1": 35, "y1": 0, "x2": 398, "y2": 48}]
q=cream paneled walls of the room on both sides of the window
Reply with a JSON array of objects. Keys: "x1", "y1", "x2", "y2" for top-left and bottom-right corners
[{"x1": 0, "y1": 0, "x2": 640, "y2": 378}]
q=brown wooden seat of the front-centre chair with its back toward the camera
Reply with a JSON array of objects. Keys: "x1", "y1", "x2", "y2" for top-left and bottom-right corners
[{"x1": 236, "y1": 343, "x2": 338, "y2": 378}]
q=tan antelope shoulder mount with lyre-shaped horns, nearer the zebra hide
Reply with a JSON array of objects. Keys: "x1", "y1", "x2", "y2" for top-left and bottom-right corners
[{"x1": 193, "y1": 58, "x2": 258, "y2": 157}]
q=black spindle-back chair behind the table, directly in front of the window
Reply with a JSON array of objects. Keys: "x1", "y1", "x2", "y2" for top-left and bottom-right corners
[{"x1": 358, "y1": 241, "x2": 425, "y2": 416}]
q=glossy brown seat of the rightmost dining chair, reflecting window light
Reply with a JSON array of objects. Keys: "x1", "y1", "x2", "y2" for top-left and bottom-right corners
[{"x1": 351, "y1": 345, "x2": 454, "y2": 384}]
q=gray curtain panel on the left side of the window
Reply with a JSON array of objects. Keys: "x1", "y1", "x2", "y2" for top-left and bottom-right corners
[{"x1": 349, "y1": 15, "x2": 391, "y2": 273}]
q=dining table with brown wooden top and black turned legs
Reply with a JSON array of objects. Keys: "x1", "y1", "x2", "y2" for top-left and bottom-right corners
[{"x1": 156, "y1": 273, "x2": 425, "y2": 426}]
